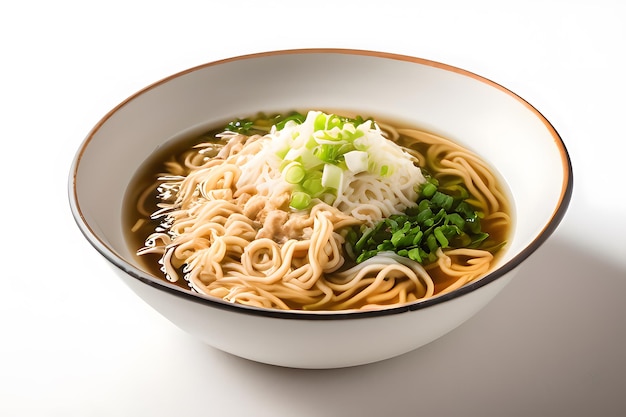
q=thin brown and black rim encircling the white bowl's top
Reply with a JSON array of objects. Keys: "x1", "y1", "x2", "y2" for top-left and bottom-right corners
[{"x1": 68, "y1": 48, "x2": 573, "y2": 320}]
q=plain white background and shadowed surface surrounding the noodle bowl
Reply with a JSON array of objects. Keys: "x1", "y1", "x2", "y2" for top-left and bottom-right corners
[{"x1": 0, "y1": 0, "x2": 626, "y2": 417}]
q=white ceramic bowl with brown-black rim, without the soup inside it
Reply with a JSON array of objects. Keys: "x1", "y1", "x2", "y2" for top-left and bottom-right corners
[{"x1": 69, "y1": 49, "x2": 572, "y2": 368}]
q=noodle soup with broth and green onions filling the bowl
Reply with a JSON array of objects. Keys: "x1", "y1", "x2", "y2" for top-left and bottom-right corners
[{"x1": 125, "y1": 110, "x2": 511, "y2": 310}]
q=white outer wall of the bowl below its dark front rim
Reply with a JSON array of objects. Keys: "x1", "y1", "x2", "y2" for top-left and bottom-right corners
[{"x1": 115, "y1": 268, "x2": 516, "y2": 369}]
